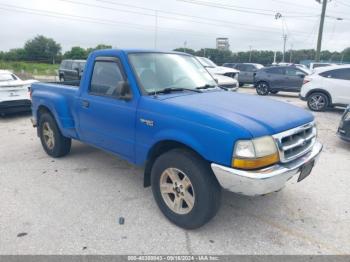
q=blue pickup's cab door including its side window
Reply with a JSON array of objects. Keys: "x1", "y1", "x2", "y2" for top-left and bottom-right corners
[{"x1": 78, "y1": 57, "x2": 136, "y2": 158}]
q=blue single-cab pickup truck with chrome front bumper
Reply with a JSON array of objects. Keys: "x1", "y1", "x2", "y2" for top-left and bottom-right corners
[{"x1": 31, "y1": 50, "x2": 322, "y2": 229}]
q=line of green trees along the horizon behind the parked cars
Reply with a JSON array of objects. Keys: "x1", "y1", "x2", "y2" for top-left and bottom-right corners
[{"x1": 0, "y1": 35, "x2": 350, "y2": 65}]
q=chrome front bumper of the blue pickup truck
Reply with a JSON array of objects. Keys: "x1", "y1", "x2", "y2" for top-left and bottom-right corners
[{"x1": 211, "y1": 142, "x2": 322, "y2": 196}]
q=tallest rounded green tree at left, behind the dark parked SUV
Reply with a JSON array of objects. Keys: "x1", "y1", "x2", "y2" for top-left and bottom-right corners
[{"x1": 24, "y1": 35, "x2": 61, "y2": 64}]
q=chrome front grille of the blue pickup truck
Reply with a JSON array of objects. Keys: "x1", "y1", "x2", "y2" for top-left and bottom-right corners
[{"x1": 273, "y1": 122, "x2": 317, "y2": 163}]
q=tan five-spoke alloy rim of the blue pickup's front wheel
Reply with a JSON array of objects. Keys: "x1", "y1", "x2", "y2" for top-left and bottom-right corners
[{"x1": 160, "y1": 168, "x2": 195, "y2": 215}]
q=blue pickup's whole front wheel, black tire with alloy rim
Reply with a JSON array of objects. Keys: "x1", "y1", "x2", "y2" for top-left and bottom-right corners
[{"x1": 151, "y1": 149, "x2": 221, "y2": 229}]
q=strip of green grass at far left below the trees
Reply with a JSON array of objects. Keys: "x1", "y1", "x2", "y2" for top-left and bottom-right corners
[{"x1": 0, "y1": 61, "x2": 60, "y2": 76}]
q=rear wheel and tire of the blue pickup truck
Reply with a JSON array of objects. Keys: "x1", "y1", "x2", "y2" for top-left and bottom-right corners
[{"x1": 38, "y1": 113, "x2": 71, "y2": 157}]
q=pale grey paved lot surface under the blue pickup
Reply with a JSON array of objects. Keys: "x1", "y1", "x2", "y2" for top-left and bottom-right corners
[{"x1": 0, "y1": 88, "x2": 350, "y2": 254}]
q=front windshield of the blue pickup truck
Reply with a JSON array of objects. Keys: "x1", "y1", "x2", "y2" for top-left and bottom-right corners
[{"x1": 129, "y1": 53, "x2": 216, "y2": 94}]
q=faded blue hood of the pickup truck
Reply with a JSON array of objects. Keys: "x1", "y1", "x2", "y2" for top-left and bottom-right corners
[{"x1": 164, "y1": 91, "x2": 314, "y2": 137}]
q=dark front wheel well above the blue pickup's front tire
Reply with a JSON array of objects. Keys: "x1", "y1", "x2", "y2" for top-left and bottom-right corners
[{"x1": 143, "y1": 140, "x2": 200, "y2": 187}]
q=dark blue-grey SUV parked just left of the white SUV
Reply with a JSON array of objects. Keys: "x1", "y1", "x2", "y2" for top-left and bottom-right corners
[{"x1": 254, "y1": 66, "x2": 308, "y2": 96}]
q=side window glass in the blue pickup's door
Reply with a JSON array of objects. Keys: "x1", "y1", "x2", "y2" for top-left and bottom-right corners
[{"x1": 89, "y1": 61, "x2": 125, "y2": 97}]
